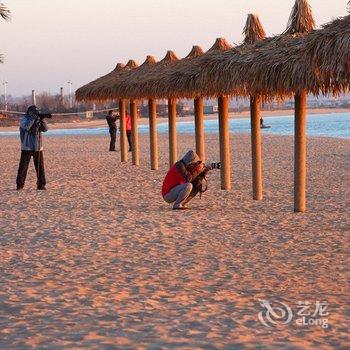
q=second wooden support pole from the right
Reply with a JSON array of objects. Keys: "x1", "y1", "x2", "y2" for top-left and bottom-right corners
[{"x1": 250, "y1": 96, "x2": 263, "y2": 201}]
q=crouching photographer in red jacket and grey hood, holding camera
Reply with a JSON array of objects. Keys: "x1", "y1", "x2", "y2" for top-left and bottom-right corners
[{"x1": 162, "y1": 150, "x2": 220, "y2": 210}]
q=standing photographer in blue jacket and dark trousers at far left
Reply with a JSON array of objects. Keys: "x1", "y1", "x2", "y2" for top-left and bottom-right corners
[{"x1": 16, "y1": 106, "x2": 52, "y2": 190}]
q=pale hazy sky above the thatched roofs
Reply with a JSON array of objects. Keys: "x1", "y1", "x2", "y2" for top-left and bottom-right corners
[{"x1": 0, "y1": 0, "x2": 347, "y2": 96}]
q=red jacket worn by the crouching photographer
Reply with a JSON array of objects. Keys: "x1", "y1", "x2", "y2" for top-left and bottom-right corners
[{"x1": 162, "y1": 160, "x2": 202, "y2": 197}]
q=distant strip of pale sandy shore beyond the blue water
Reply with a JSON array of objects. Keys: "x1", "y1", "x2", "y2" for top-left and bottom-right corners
[{"x1": 0, "y1": 108, "x2": 350, "y2": 132}]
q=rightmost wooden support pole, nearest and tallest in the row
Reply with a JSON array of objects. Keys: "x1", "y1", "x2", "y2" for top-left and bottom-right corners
[{"x1": 294, "y1": 91, "x2": 307, "y2": 213}]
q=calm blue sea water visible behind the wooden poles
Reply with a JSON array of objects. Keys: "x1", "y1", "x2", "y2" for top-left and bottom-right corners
[{"x1": 0, "y1": 113, "x2": 350, "y2": 138}]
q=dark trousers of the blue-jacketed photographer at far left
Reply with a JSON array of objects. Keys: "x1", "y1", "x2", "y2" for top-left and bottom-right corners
[{"x1": 16, "y1": 151, "x2": 46, "y2": 188}]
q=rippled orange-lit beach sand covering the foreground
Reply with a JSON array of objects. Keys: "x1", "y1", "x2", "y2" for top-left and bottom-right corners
[{"x1": 0, "y1": 134, "x2": 350, "y2": 349}]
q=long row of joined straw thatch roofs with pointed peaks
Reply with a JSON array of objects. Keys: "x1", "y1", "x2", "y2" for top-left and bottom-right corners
[{"x1": 76, "y1": 0, "x2": 350, "y2": 99}]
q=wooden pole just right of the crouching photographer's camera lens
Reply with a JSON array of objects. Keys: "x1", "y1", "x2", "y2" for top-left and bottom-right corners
[{"x1": 218, "y1": 96, "x2": 231, "y2": 190}]
